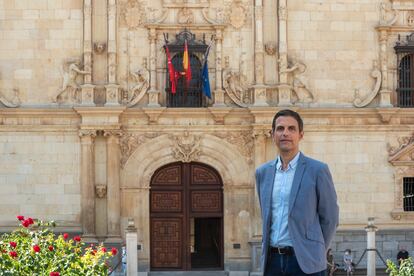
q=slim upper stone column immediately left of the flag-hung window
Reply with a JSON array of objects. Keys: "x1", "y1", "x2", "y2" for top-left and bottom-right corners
[{"x1": 148, "y1": 28, "x2": 160, "y2": 107}]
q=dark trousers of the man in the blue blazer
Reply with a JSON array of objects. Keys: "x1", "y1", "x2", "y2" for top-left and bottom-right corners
[{"x1": 263, "y1": 252, "x2": 326, "y2": 276}]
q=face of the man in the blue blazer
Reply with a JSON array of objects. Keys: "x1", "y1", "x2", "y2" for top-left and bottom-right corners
[{"x1": 273, "y1": 116, "x2": 303, "y2": 153}]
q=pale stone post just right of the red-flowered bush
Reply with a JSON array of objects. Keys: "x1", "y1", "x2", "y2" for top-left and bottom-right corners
[{"x1": 125, "y1": 219, "x2": 138, "y2": 276}]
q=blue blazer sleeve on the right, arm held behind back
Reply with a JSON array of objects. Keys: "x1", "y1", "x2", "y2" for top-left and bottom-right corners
[{"x1": 317, "y1": 164, "x2": 339, "y2": 249}]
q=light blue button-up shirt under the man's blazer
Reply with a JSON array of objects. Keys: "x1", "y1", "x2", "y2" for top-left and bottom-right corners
[{"x1": 270, "y1": 152, "x2": 300, "y2": 247}]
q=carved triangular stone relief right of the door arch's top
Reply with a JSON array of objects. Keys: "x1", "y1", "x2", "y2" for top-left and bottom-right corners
[{"x1": 212, "y1": 131, "x2": 254, "y2": 161}]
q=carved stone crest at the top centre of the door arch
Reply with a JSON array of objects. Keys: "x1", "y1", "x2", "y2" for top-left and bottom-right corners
[{"x1": 169, "y1": 132, "x2": 201, "y2": 163}]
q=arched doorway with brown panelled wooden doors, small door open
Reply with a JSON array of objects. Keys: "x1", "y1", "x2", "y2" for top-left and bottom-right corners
[{"x1": 150, "y1": 162, "x2": 224, "y2": 270}]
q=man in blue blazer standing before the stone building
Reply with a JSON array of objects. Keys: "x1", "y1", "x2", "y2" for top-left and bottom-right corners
[{"x1": 256, "y1": 110, "x2": 339, "y2": 276}]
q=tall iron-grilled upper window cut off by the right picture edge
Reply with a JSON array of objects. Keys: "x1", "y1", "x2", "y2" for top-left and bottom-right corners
[{"x1": 394, "y1": 33, "x2": 414, "y2": 107}]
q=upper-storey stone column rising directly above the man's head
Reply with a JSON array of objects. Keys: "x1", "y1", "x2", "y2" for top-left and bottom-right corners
[{"x1": 278, "y1": 0, "x2": 292, "y2": 106}]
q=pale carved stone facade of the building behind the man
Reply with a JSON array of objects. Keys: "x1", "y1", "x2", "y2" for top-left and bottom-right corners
[{"x1": 0, "y1": 0, "x2": 414, "y2": 271}]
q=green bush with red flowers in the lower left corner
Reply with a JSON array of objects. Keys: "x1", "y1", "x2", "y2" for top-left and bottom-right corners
[{"x1": 0, "y1": 216, "x2": 117, "y2": 276}]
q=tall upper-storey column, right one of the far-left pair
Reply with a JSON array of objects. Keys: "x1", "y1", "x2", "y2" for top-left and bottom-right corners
[{"x1": 105, "y1": 0, "x2": 119, "y2": 106}]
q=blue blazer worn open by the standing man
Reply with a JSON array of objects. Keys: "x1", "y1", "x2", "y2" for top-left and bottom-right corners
[{"x1": 256, "y1": 153, "x2": 339, "y2": 274}]
